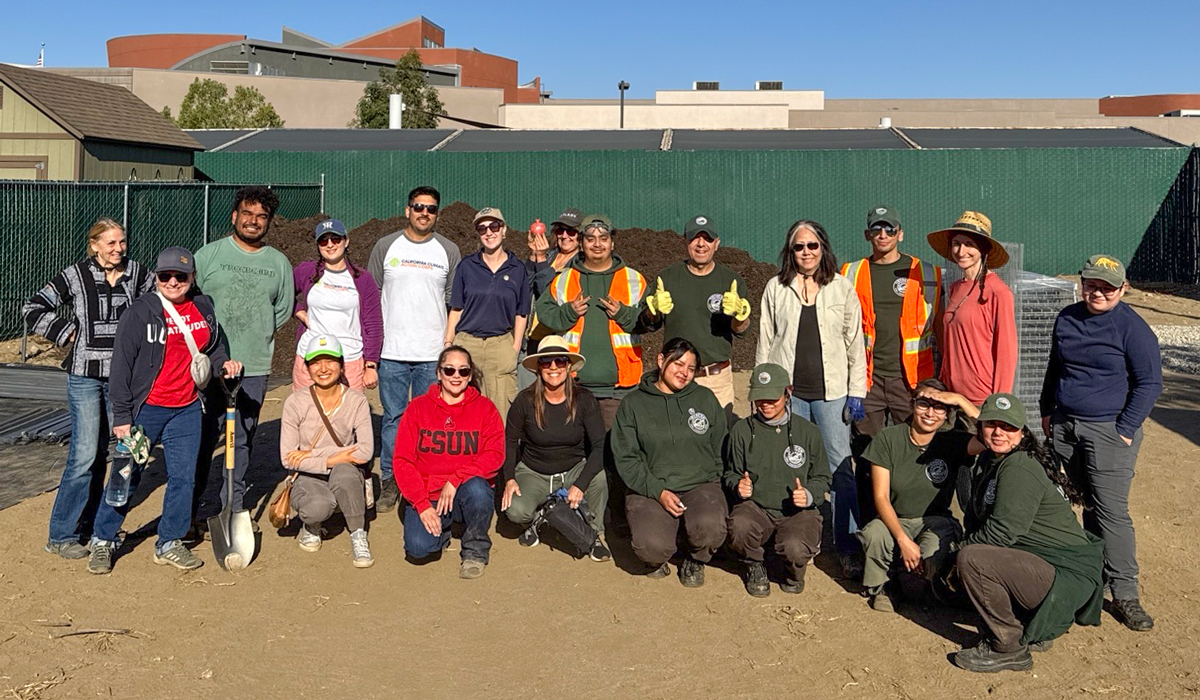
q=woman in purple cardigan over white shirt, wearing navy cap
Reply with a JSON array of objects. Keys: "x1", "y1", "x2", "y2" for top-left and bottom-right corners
[{"x1": 292, "y1": 219, "x2": 383, "y2": 391}]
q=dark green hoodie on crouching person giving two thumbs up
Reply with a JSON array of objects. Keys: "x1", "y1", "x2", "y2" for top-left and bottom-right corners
[{"x1": 725, "y1": 413, "x2": 830, "y2": 515}]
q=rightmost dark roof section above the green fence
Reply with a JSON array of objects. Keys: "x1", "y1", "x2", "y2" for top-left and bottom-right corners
[{"x1": 899, "y1": 127, "x2": 1180, "y2": 149}]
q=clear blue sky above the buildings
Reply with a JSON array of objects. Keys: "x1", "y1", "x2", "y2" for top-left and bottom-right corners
[{"x1": 0, "y1": 0, "x2": 1200, "y2": 98}]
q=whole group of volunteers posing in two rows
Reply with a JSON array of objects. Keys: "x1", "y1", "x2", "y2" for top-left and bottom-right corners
[{"x1": 23, "y1": 186, "x2": 1162, "y2": 671}]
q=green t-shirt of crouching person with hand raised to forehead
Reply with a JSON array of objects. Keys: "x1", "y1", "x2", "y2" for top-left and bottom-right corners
[{"x1": 863, "y1": 424, "x2": 972, "y2": 517}]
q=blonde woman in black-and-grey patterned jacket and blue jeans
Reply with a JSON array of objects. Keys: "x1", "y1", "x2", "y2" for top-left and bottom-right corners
[{"x1": 20, "y1": 219, "x2": 154, "y2": 560}]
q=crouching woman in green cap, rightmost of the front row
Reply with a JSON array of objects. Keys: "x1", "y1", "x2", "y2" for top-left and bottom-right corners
[{"x1": 938, "y1": 394, "x2": 1104, "y2": 672}]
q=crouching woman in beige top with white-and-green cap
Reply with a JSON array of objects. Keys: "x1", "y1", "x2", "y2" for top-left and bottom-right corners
[{"x1": 280, "y1": 335, "x2": 374, "y2": 569}]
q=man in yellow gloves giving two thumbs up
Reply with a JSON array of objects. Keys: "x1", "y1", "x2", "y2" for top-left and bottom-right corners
[{"x1": 642, "y1": 215, "x2": 751, "y2": 418}]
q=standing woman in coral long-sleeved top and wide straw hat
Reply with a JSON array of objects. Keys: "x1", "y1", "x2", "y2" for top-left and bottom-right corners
[{"x1": 928, "y1": 211, "x2": 1016, "y2": 406}]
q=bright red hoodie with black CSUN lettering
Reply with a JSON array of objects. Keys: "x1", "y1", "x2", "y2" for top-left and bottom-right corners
[{"x1": 392, "y1": 383, "x2": 504, "y2": 513}]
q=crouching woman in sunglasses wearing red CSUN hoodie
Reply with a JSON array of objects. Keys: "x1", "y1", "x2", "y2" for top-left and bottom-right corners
[{"x1": 392, "y1": 345, "x2": 504, "y2": 579}]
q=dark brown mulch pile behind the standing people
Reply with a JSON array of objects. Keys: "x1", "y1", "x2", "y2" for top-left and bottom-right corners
[{"x1": 268, "y1": 202, "x2": 778, "y2": 376}]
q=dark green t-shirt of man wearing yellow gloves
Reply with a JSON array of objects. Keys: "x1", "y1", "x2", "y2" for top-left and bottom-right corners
[{"x1": 646, "y1": 262, "x2": 750, "y2": 366}]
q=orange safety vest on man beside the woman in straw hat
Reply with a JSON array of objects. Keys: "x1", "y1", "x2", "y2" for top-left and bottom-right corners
[{"x1": 841, "y1": 258, "x2": 942, "y2": 389}]
